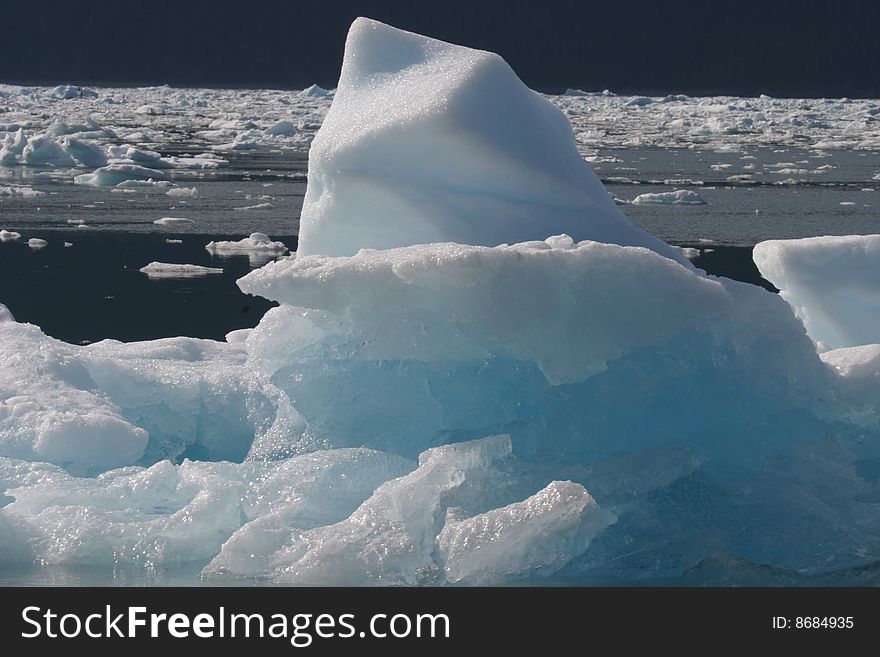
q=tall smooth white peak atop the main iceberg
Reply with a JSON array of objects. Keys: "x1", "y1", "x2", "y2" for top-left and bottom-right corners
[{"x1": 299, "y1": 18, "x2": 683, "y2": 260}]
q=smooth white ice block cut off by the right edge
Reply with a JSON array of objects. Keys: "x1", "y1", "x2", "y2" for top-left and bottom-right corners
[{"x1": 753, "y1": 235, "x2": 880, "y2": 348}]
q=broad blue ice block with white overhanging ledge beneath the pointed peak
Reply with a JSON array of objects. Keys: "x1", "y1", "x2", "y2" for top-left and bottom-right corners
[{"x1": 239, "y1": 236, "x2": 831, "y2": 470}]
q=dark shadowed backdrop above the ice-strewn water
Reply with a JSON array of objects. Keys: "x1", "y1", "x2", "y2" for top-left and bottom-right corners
[{"x1": 0, "y1": 0, "x2": 880, "y2": 98}]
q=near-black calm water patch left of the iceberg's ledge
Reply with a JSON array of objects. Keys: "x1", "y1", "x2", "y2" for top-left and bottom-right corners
[{"x1": 0, "y1": 231, "x2": 296, "y2": 343}]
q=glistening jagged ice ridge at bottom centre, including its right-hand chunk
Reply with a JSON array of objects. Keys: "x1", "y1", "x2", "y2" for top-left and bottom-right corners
[{"x1": 205, "y1": 436, "x2": 613, "y2": 585}]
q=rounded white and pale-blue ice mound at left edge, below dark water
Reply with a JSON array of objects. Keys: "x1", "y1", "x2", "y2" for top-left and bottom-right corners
[{"x1": 0, "y1": 316, "x2": 276, "y2": 473}]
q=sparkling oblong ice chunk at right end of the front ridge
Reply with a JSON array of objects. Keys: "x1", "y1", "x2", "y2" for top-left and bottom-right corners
[{"x1": 437, "y1": 481, "x2": 614, "y2": 586}]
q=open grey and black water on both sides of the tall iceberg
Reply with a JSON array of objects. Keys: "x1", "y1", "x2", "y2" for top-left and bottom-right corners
[{"x1": 0, "y1": 147, "x2": 880, "y2": 343}]
